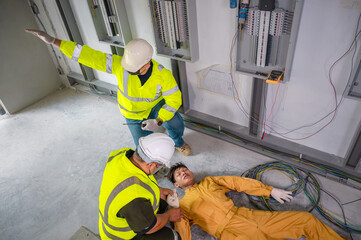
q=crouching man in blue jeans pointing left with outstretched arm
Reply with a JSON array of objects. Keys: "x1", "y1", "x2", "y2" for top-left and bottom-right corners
[{"x1": 26, "y1": 29, "x2": 192, "y2": 156}]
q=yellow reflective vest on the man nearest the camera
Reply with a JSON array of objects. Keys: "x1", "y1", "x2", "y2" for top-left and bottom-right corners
[{"x1": 99, "y1": 148, "x2": 160, "y2": 239}]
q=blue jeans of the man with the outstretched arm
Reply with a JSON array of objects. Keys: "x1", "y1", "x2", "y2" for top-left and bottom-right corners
[{"x1": 125, "y1": 99, "x2": 184, "y2": 147}]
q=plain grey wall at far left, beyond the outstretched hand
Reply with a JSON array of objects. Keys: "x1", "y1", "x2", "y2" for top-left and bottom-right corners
[{"x1": 0, "y1": 0, "x2": 61, "y2": 113}]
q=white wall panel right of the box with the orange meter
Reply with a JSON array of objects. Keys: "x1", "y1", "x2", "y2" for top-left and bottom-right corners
[{"x1": 267, "y1": 0, "x2": 361, "y2": 157}]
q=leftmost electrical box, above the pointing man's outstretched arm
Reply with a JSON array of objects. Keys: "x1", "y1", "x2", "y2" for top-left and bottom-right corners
[{"x1": 87, "y1": 0, "x2": 132, "y2": 48}]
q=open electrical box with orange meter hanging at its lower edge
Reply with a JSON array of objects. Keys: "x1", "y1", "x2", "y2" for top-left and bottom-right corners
[{"x1": 236, "y1": 0, "x2": 303, "y2": 81}]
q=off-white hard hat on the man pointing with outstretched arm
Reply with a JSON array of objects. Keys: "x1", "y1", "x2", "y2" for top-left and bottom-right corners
[{"x1": 121, "y1": 39, "x2": 153, "y2": 72}]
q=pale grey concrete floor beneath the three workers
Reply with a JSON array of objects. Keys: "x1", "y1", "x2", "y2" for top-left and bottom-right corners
[{"x1": 0, "y1": 89, "x2": 361, "y2": 240}]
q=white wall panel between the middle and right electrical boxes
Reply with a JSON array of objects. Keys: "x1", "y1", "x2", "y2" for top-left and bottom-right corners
[{"x1": 186, "y1": 0, "x2": 252, "y2": 126}]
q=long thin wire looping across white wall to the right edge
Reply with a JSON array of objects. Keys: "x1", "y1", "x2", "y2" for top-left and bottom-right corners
[{"x1": 229, "y1": 27, "x2": 361, "y2": 140}]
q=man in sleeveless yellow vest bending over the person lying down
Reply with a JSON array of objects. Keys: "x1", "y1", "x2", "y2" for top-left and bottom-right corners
[{"x1": 99, "y1": 133, "x2": 183, "y2": 240}]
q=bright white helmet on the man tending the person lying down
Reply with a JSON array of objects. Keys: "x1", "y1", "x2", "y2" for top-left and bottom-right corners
[{"x1": 136, "y1": 133, "x2": 174, "y2": 167}]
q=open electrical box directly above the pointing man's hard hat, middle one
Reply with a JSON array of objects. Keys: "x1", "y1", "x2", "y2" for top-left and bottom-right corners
[{"x1": 149, "y1": 0, "x2": 198, "y2": 61}]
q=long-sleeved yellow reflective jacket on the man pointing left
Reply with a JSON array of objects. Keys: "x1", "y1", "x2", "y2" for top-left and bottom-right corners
[{"x1": 60, "y1": 40, "x2": 182, "y2": 121}]
